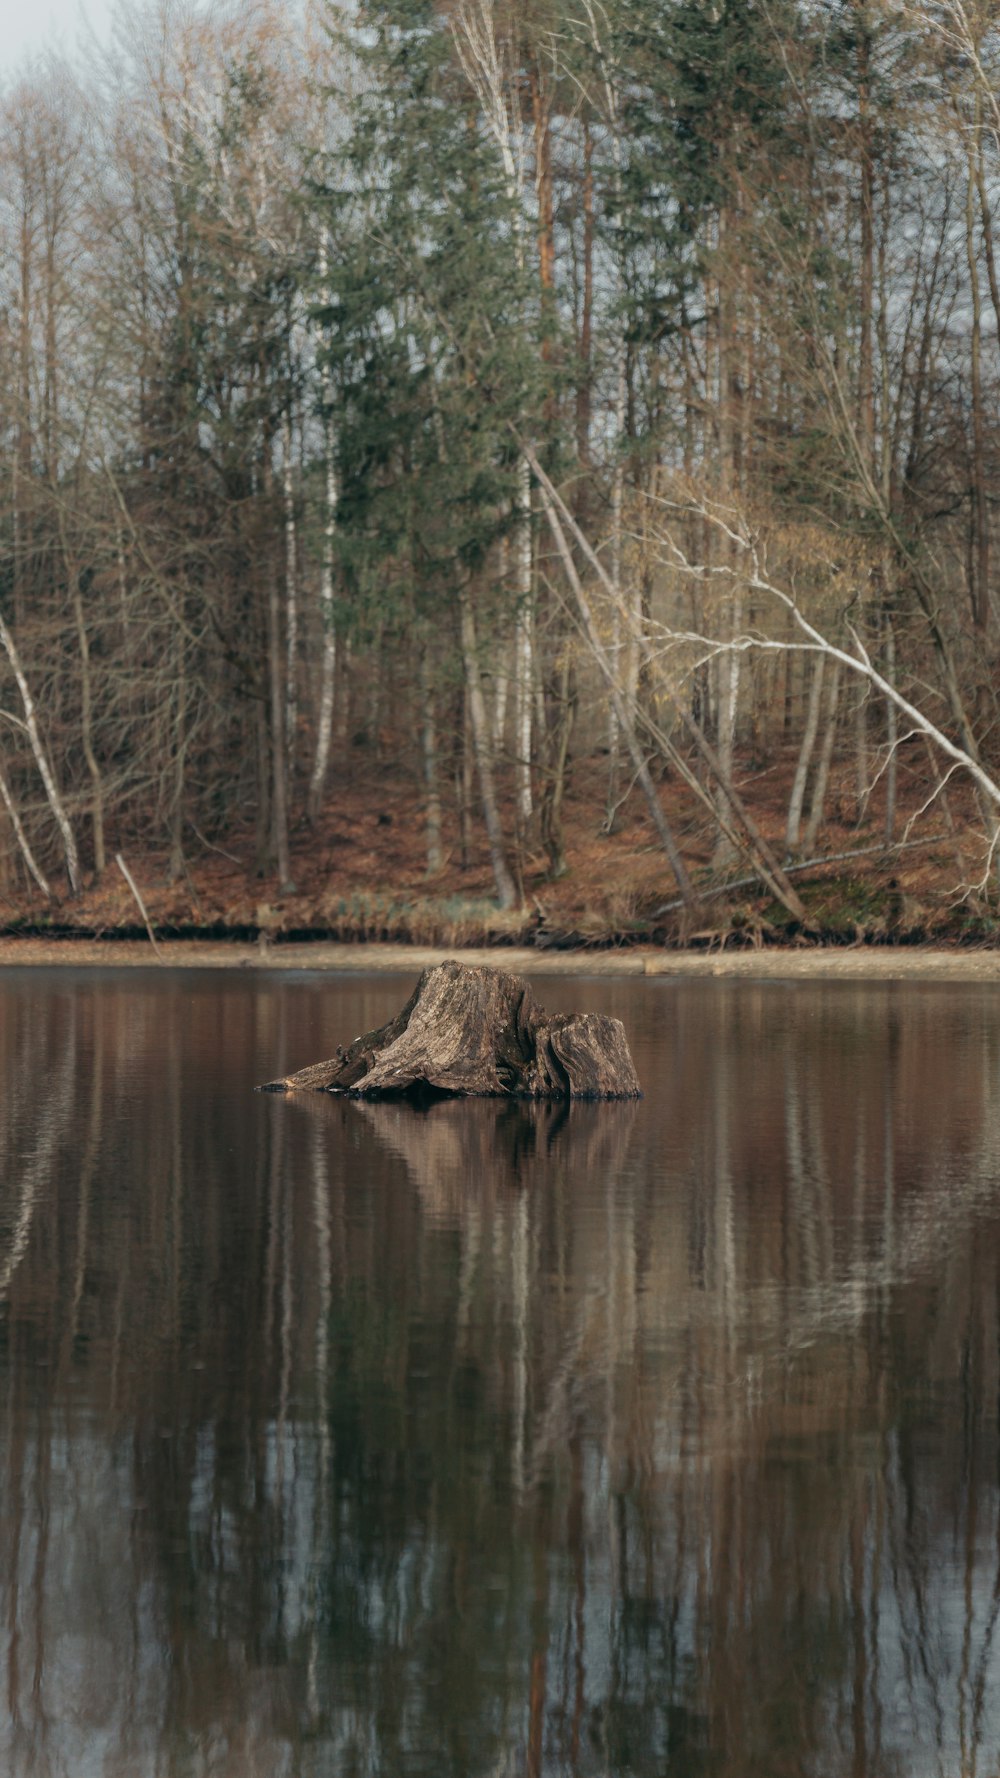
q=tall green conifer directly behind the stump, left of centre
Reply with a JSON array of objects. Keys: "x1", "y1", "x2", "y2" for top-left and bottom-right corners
[{"x1": 319, "y1": 0, "x2": 552, "y2": 905}]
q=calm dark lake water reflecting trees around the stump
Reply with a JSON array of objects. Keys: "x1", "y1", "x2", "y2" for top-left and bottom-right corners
[{"x1": 0, "y1": 969, "x2": 1000, "y2": 1778}]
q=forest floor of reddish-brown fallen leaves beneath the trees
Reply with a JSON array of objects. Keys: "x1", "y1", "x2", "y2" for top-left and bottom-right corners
[{"x1": 0, "y1": 736, "x2": 1000, "y2": 967}]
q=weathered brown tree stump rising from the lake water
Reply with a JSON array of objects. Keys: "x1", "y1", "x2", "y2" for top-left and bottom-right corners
[{"x1": 262, "y1": 964, "x2": 641, "y2": 1099}]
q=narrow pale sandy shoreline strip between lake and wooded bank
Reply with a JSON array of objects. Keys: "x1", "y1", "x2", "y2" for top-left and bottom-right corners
[{"x1": 0, "y1": 939, "x2": 1000, "y2": 981}]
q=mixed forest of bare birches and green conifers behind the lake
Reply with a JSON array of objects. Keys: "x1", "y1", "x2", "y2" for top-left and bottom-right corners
[{"x1": 0, "y1": 0, "x2": 1000, "y2": 944}]
